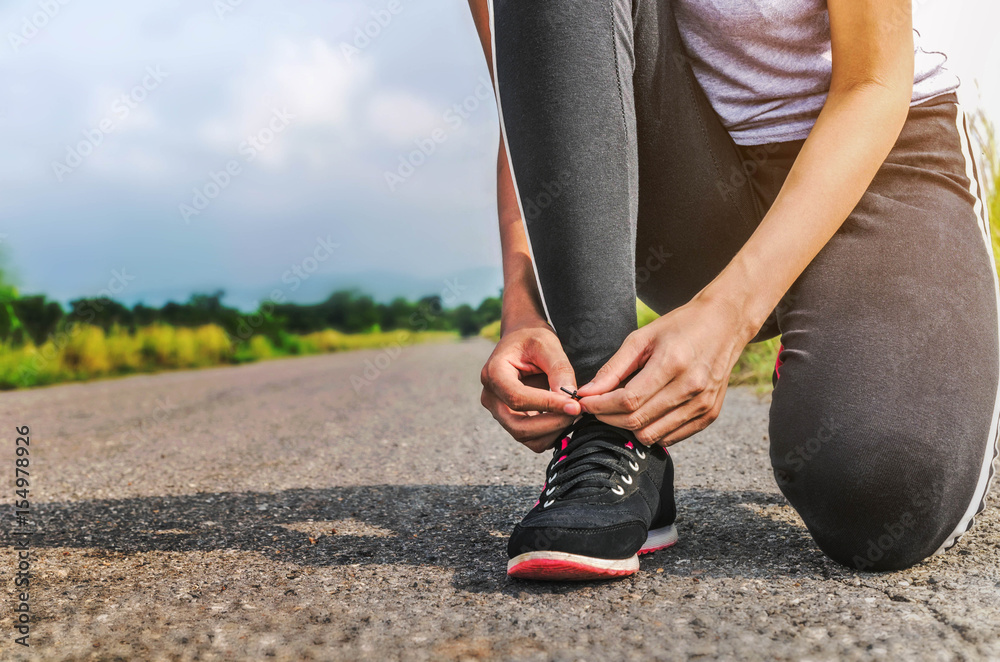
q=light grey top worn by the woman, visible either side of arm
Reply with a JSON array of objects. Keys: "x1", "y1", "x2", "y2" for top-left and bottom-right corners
[{"x1": 675, "y1": 0, "x2": 959, "y2": 145}]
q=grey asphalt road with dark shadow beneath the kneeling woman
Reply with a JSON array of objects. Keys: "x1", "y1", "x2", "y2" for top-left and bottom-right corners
[{"x1": 0, "y1": 341, "x2": 1000, "y2": 660}]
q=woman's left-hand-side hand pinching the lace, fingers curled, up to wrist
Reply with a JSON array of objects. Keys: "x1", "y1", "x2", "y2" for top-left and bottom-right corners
[{"x1": 480, "y1": 320, "x2": 581, "y2": 453}]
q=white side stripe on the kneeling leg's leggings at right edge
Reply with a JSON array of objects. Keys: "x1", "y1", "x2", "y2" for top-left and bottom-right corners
[{"x1": 935, "y1": 94, "x2": 1000, "y2": 554}]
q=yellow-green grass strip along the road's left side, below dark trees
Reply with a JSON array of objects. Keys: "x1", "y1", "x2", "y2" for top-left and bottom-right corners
[{"x1": 0, "y1": 324, "x2": 458, "y2": 390}]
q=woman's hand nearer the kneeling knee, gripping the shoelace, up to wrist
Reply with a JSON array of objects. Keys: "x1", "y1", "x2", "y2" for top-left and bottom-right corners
[{"x1": 579, "y1": 297, "x2": 753, "y2": 446}]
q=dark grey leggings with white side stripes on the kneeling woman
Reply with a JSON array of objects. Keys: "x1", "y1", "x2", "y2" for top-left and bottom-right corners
[{"x1": 492, "y1": 0, "x2": 1000, "y2": 570}]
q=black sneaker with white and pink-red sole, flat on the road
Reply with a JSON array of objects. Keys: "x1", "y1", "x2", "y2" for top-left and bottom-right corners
[{"x1": 507, "y1": 414, "x2": 677, "y2": 580}]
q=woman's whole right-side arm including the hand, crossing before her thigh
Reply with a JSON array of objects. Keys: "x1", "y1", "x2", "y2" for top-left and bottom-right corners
[{"x1": 579, "y1": 0, "x2": 913, "y2": 445}]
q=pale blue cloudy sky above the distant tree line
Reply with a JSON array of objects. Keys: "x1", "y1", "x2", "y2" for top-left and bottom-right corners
[{"x1": 0, "y1": 0, "x2": 1000, "y2": 308}]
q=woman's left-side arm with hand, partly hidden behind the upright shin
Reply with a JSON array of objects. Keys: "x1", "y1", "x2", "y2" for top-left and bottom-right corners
[{"x1": 469, "y1": 0, "x2": 581, "y2": 452}]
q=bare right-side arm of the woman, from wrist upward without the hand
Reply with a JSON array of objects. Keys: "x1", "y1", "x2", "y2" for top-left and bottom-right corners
[{"x1": 703, "y1": 0, "x2": 913, "y2": 337}]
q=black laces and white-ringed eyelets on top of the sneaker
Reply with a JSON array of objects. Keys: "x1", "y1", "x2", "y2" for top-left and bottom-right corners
[{"x1": 539, "y1": 415, "x2": 646, "y2": 508}]
